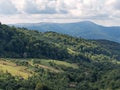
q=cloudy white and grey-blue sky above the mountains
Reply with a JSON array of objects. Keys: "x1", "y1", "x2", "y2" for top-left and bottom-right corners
[{"x1": 0, "y1": 0, "x2": 120, "y2": 26}]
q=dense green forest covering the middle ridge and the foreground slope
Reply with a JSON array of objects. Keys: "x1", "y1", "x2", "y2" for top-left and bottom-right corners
[{"x1": 0, "y1": 25, "x2": 120, "y2": 90}]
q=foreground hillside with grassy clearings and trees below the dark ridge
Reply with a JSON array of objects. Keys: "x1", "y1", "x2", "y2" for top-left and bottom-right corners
[{"x1": 0, "y1": 59, "x2": 120, "y2": 90}]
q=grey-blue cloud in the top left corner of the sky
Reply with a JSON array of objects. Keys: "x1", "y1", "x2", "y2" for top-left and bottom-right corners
[{"x1": 0, "y1": 0, "x2": 18, "y2": 15}]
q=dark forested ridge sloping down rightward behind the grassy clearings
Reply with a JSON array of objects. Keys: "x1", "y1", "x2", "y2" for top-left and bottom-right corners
[{"x1": 0, "y1": 25, "x2": 120, "y2": 62}]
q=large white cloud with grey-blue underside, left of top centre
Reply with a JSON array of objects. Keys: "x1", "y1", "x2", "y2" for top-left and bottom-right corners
[{"x1": 23, "y1": 0, "x2": 67, "y2": 14}]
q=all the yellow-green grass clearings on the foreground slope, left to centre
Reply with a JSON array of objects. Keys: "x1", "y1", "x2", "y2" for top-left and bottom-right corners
[{"x1": 0, "y1": 58, "x2": 78, "y2": 79}]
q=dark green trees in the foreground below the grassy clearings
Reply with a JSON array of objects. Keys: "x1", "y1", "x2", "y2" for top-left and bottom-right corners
[{"x1": 0, "y1": 59, "x2": 120, "y2": 90}]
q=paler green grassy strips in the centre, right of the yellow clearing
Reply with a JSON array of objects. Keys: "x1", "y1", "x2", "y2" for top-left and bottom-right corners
[{"x1": 29, "y1": 59, "x2": 79, "y2": 73}]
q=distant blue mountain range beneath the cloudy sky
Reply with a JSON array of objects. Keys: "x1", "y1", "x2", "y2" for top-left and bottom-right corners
[{"x1": 10, "y1": 21, "x2": 120, "y2": 43}]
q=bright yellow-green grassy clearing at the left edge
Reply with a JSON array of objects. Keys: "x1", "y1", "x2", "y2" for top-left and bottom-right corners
[{"x1": 0, "y1": 60, "x2": 32, "y2": 79}]
